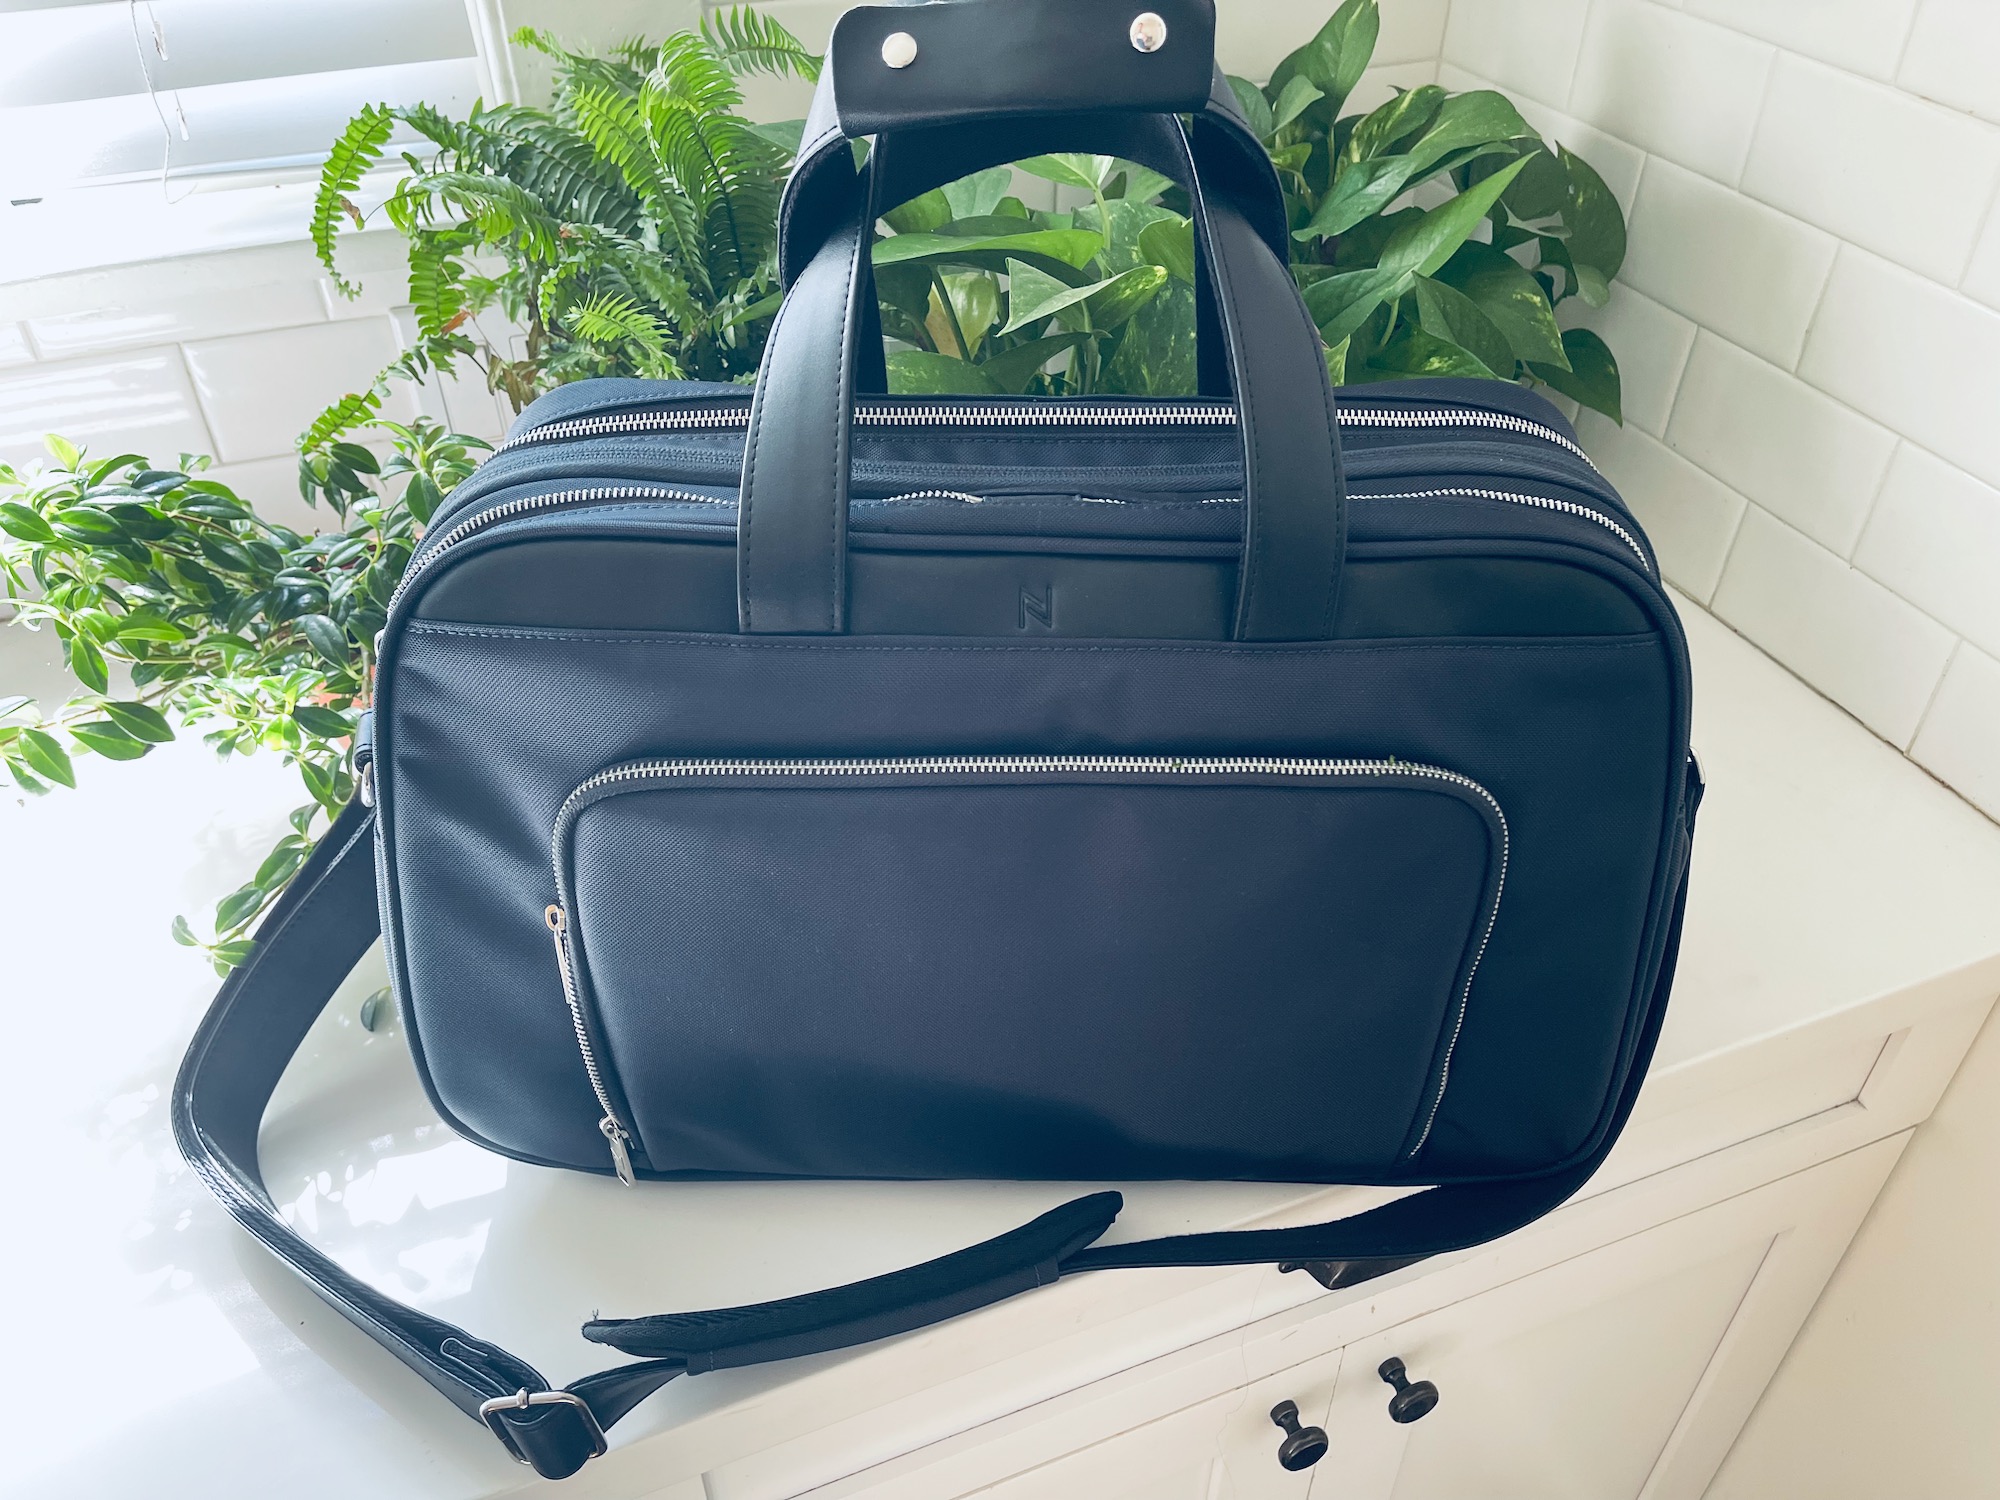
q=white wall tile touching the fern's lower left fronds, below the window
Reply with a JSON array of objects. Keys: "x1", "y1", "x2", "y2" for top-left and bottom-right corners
[{"x1": 186, "y1": 318, "x2": 416, "y2": 464}]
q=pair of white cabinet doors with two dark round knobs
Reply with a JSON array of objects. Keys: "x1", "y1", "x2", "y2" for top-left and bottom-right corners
[{"x1": 818, "y1": 1136, "x2": 1904, "y2": 1500}]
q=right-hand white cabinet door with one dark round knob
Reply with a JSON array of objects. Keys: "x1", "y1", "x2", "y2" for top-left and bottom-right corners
[{"x1": 1312, "y1": 1140, "x2": 1902, "y2": 1500}]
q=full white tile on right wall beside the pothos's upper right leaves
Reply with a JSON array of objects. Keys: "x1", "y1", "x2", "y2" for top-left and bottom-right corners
[{"x1": 1620, "y1": 158, "x2": 1834, "y2": 368}]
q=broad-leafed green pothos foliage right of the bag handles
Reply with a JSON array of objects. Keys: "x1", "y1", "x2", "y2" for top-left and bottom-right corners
[{"x1": 1256, "y1": 0, "x2": 1626, "y2": 422}]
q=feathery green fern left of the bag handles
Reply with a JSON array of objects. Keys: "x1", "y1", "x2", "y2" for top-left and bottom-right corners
[{"x1": 300, "y1": 8, "x2": 820, "y2": 496}]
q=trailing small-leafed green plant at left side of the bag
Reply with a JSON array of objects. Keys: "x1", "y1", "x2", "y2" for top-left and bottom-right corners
[{"x1": 0, "y1": 422, "x2": 484, "y2": 972}]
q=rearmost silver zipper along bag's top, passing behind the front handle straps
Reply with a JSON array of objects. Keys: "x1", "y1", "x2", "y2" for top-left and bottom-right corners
[{"x1": 500, "y1": 400, "x2": 1596, "y2": 470}]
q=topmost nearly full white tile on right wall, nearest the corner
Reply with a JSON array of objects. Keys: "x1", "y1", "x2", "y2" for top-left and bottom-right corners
[{"x1": 1568, "y1": 0, "x2": 1774, "y2": 182}]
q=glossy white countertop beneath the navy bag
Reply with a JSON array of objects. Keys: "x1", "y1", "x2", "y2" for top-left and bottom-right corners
[{"x1": 0, "y1": 606, "x2": 2000, "y2": 1500}]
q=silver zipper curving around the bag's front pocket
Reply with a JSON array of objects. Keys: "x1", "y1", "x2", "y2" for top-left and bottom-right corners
[{"x1": 546, "y1": 756, "x2": 1510, "y2": 1180}]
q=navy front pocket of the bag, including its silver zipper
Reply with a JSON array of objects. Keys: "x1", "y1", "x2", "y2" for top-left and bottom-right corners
[{"x1": 548, "y1": 756, "x2": 1508, "y2": 1180}]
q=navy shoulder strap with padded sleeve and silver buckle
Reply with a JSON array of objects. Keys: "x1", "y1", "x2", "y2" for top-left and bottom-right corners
[{"x1": 172, "y1": 766, "x2": 1700, "y2": 1478}]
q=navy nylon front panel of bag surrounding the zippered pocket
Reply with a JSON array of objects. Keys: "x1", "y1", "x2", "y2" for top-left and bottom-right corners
[{"x1": 378, "y1": 622, "x2": 1684, "y2": 1180}]
